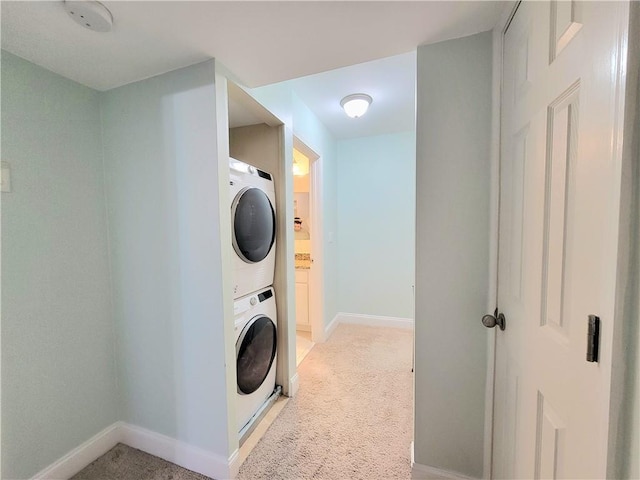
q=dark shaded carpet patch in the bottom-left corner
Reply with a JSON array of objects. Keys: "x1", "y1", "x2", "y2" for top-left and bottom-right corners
[{"x1": 71, "y1": 443, "x2": 210, "y2": 480}]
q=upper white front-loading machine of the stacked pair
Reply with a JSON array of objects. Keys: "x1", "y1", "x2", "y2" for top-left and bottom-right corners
[{"x1": 229, "y1": 158, "x2": 276, "y2": 299}]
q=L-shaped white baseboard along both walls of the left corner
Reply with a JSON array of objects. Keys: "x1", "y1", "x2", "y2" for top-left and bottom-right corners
[{"x1": 32, "y1": 422, "x2": 240, "y2": 480}]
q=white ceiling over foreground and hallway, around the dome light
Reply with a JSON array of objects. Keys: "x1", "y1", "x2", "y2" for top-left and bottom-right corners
[{"x1": 0, "y1": 0, "x2": 502, "y2": 138}]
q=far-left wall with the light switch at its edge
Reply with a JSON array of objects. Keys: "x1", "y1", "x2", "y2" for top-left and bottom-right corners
[{"x1": 1, "y1": 51, "x2": 118, "y2": 479}]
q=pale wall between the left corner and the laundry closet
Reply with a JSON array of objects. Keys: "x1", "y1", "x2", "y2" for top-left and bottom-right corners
[{"x1": 101, "y1": 61, "x2": 230, "y2": 459}]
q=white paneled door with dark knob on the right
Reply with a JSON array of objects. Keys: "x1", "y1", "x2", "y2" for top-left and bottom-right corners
[{"x1": 492, "y1": 1, "x2": 628, "y2": 479}]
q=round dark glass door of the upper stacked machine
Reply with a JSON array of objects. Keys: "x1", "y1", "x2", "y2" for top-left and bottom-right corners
[{"x1": 231, "y1": 187, "x2": 276, "y2": 263}]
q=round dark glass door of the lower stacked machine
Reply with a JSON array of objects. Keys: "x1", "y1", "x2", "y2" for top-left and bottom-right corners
[{"x1": 236, "y1": 315, "x2": 277, "y2": 395}]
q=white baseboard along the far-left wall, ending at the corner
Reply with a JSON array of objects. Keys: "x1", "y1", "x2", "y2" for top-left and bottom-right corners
[{"x1": 32, "y1": 422, "x2": 122, "y2": 480}]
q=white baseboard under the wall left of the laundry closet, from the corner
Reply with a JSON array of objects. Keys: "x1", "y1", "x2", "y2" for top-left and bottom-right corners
[{"x1": 121, "y1": 424, "x2": 235, "y2": 479}]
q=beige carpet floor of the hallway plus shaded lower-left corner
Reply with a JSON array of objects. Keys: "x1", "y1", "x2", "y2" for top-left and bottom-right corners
[{"x1": 74, "y1": 324, "x2": 413, "y2": 480}]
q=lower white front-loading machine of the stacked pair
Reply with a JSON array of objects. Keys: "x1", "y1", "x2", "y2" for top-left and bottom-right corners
[{"x1": 233, "y1": 287, "x2": 278, "y2": 432}]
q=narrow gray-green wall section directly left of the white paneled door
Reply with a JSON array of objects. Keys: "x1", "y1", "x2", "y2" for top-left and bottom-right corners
[{"x1": 414, "y1": 32, "x2": 492, "y2": 478}]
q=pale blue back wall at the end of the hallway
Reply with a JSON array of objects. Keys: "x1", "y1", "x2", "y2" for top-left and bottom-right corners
[{"x1": 337, "y1": 132, "x2": 416, "y2": 318}]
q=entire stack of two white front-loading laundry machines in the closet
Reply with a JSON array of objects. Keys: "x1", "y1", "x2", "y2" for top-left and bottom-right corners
[{"x1": 229, "y1": 158, "x2": 278, "y2": 441}]
